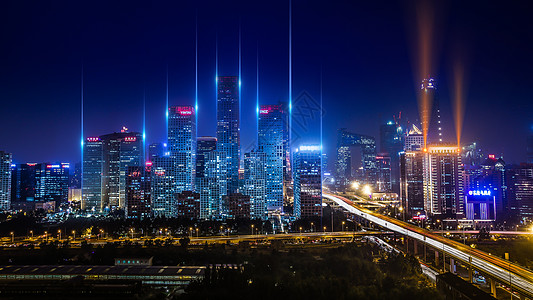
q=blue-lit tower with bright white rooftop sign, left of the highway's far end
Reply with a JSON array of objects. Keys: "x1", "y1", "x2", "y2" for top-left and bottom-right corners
[{"x1": 293, "y1": 146, "x2": 322, "y2": 218}]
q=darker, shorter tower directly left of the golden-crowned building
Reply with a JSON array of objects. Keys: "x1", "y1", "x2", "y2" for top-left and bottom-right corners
[{"x1": 400, "y1": 151, "x2": 424, "y2": 216}]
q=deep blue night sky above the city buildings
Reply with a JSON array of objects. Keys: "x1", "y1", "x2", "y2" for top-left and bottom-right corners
[{"x1": 0, "y1": 0, "x2": 533, "y2": 163}]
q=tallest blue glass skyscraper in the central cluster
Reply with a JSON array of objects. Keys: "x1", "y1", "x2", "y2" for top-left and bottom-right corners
[{"x1": 217, "y1": 76, "x2": 240, "y2": 194}]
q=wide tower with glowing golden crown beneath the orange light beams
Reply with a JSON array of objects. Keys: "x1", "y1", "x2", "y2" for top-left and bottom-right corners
[{"x1": 424, "y1": 145, "x2": 465, "y2": 220}]
